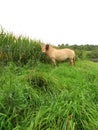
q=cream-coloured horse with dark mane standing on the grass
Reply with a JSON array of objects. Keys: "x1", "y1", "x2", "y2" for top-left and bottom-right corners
[{"x1": 41, "y1": 44, "x2": 75, "y2": 65}]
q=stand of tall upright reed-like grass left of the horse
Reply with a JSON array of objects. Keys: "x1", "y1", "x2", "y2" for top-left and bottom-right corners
[{"x1": 0, "y1": 29, "x2": 41, "y2": 64}]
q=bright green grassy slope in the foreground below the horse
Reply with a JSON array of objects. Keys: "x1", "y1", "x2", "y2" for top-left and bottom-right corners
[{"x1": 0, "y1": 61, "x2": 98, "y2": 130}]
